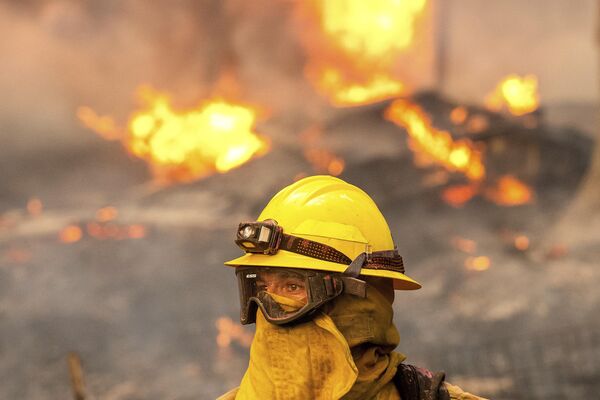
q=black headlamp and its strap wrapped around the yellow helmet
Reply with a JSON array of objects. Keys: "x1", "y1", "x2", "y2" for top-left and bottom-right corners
[{"x1": 235, "y1": 219, "x2": 404, "y2": 277}]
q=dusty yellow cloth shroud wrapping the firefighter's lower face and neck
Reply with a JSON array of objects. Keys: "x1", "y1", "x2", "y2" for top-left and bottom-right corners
[{"x1": 218, "y1": 286, "x2": 488, "y2": 400}]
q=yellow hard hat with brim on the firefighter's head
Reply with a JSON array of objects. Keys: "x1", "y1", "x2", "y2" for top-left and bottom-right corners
[{"x1": 225, "y1": 176, "x2": 421, "y2": 290}]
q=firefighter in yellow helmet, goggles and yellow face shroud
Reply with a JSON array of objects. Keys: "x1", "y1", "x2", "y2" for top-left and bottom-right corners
[{"x1": 219, "y1": 176, "x2": 480, "y2": 400}]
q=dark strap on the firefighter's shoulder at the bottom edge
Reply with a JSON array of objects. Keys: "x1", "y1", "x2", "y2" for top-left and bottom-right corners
[{"x1": 394, "y1": 364, "x2": 450, "y2": 400}]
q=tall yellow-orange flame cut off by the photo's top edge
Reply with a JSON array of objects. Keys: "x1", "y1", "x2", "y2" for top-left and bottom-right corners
[{"x1": 297, "y1": 0, "x2": 426, "y2": 106}]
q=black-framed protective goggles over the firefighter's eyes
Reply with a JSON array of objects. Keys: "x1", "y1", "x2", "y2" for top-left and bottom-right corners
[{"x1": 236, "y1": 267, "x2": 366, "y2": 325}]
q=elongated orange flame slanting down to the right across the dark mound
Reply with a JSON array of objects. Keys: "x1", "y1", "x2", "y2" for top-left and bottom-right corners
[{"x1": 385, "y1": 99, "x2": 485, "y2": 181}]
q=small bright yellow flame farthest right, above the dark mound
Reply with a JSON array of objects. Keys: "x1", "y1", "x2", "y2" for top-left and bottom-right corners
[{"x1": 485, "y1": 74, "x2": 540, "y2": 116}]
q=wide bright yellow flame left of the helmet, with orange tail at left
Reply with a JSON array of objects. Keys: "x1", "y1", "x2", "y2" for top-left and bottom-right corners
[{"x1": 78, "y1": 87, "x2": 269, "y2": 182}]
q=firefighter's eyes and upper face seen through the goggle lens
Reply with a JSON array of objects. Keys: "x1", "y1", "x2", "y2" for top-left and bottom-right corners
[{"x1": 256, "y1": 269, "x2": 308, "y2": 305}]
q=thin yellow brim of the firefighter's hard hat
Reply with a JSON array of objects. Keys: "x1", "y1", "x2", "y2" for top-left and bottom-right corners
[{"x1": 225, "y1": 250, "x2": 421, "y2": 290}]
